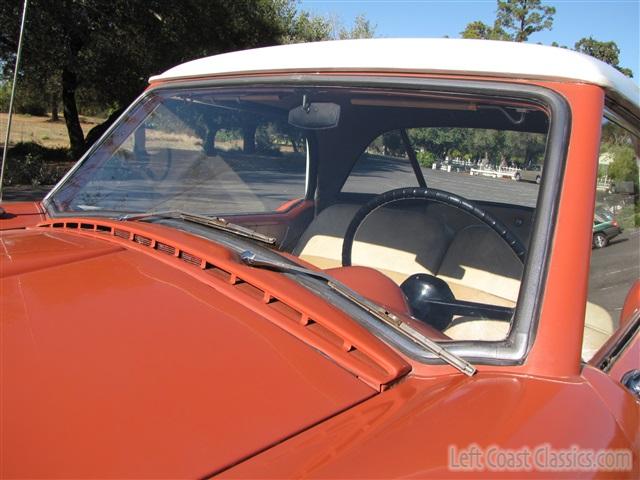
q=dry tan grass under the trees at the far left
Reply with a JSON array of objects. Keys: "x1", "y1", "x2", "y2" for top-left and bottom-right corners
[{"x1": 0, "y1": 113, "x2": 104, "y2": 148}]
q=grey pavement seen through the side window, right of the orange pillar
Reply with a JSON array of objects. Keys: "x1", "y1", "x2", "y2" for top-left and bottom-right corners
[{"x1": 589, "y1": 228, "x2": 640, "y2": 327}]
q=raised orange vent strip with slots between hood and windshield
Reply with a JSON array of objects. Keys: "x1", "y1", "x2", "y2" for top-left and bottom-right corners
[{"x1": 38, "y1": 219, "x2": 410, "y2": 390}]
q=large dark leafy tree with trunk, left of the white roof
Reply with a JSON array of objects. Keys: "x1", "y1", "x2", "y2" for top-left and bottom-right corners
[{"x1": 0, "y1": 0, "x2": 296, "y2": 158}]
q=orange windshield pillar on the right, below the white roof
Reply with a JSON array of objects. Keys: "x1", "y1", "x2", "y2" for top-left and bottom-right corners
[{"x1": 516, "y1": 84, "x2": 604, "y2": 377}]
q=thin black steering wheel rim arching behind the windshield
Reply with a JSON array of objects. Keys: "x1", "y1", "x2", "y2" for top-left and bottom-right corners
[{"x1": 342, "y1": 187, "x2": 527, "y2": 267}]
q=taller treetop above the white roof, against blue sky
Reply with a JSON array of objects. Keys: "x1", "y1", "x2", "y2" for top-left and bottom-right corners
[{"x1": 460, "y1": 0, "x2": 556, "y2": 42}]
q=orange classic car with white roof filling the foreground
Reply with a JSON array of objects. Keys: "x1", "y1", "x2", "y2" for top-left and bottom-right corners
[{"x1": 0, "y1": 39, "x2": 640, "y2": 478}]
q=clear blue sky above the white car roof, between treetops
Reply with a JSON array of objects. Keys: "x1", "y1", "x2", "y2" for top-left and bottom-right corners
[{"x1": 300, "y1": 0, "x2": 640, "y2": 83}]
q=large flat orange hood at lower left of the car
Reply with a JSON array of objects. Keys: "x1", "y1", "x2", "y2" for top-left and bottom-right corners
[{"x1": 0, "y1": 228, "x2": 376, "y2": 478}]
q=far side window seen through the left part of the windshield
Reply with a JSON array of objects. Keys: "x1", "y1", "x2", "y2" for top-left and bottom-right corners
[{"x1": 52, "y1": 90, "x2": 307, "y2": 214}]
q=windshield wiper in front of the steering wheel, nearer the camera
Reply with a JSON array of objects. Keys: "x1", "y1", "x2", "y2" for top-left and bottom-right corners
[{"x1": 240, "y1": 250, "x2": 476, "y2": 376}]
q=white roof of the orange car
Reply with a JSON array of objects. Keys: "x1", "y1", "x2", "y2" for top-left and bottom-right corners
[{"x1": 149, "y1": 38, "x2": 640, "y2": 112}]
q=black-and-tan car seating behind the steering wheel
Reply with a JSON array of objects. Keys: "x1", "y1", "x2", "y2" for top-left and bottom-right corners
[{"x1": 294, "y1": 204, "x2": 613, "y2": 360}]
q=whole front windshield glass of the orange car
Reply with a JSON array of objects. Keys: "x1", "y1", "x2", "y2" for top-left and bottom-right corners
[{"x1": 46, "y1": 81, "x2": 553, "y2": 362}]
